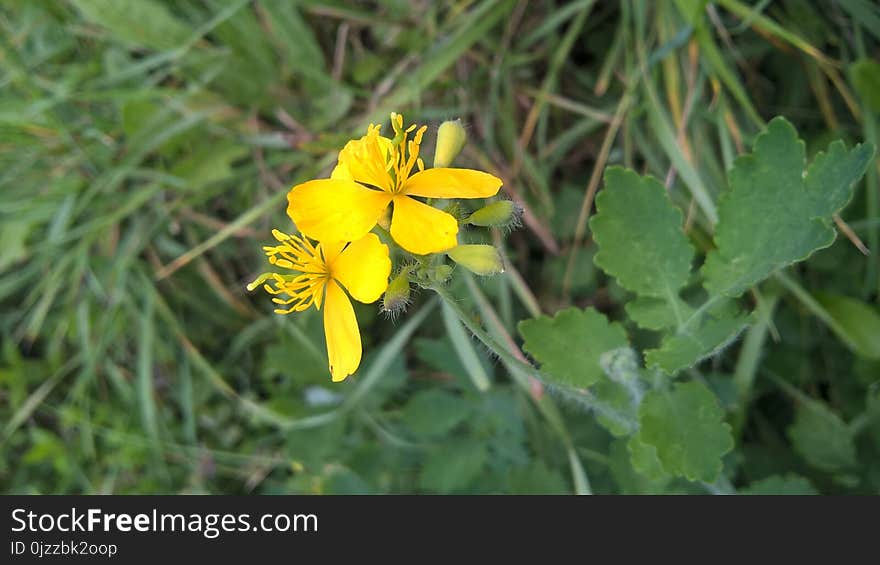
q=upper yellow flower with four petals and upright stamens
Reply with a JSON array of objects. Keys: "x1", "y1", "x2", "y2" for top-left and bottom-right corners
[{"x1": 287, "y1": 114, "x2": 501, "y2": 255}]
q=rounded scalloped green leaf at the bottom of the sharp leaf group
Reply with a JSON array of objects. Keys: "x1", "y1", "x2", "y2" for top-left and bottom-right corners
[{"x1": 638, "y1": 382, "x2": 733, "y2": 482}]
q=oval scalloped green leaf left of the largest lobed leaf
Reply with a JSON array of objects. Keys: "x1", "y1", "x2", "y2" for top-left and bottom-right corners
[{"x1": 590, "y1": 167, "x2": 694, "y2": 301}]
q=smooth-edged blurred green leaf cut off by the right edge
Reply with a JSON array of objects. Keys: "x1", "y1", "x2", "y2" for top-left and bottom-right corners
[{"x1": 816, "y1": 293, "x2": 880, "y2": 359}]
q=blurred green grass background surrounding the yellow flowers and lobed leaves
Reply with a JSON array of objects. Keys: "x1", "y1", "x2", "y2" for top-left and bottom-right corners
[{"x1": 0, "y1": 0, "x2": 880, "y2": 493}]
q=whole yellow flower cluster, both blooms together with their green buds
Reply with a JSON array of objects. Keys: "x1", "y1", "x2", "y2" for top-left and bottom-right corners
[{"x1": 248, "y1": 113, "x2": 516, "y2": 381}]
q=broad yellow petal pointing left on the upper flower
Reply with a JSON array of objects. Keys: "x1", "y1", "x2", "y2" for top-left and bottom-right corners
[{"x1": 287, "y1": 179, "x2": 391, "y2": 241}]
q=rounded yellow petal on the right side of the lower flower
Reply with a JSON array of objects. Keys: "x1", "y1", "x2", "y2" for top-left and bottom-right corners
[{"x1": 330, "y1": 233, "x2": 391, "y2": 304}]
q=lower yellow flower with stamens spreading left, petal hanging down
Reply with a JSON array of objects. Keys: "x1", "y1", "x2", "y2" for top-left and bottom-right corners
[{"x1": 248, "y1": 230, "x2": 391, "y2": 381}]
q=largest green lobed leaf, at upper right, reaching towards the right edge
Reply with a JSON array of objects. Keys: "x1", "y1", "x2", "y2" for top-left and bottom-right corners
[{"x1": 703, "y1": 118, "x2": 874, "y2": 297}]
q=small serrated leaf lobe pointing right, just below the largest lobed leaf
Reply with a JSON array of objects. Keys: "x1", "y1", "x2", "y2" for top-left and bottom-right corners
[{"x1": 645, "y1": 306, "x2": 749, "y2": 375}]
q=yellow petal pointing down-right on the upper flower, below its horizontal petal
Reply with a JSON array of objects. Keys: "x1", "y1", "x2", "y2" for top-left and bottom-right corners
[{"x1": 391, "y1": 195, "x2": 458, "y2": 255}]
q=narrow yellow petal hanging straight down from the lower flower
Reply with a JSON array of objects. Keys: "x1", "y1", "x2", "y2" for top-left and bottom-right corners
[{"x1": 324, "y1": 281, "x2": 361, "y2": 382}]
